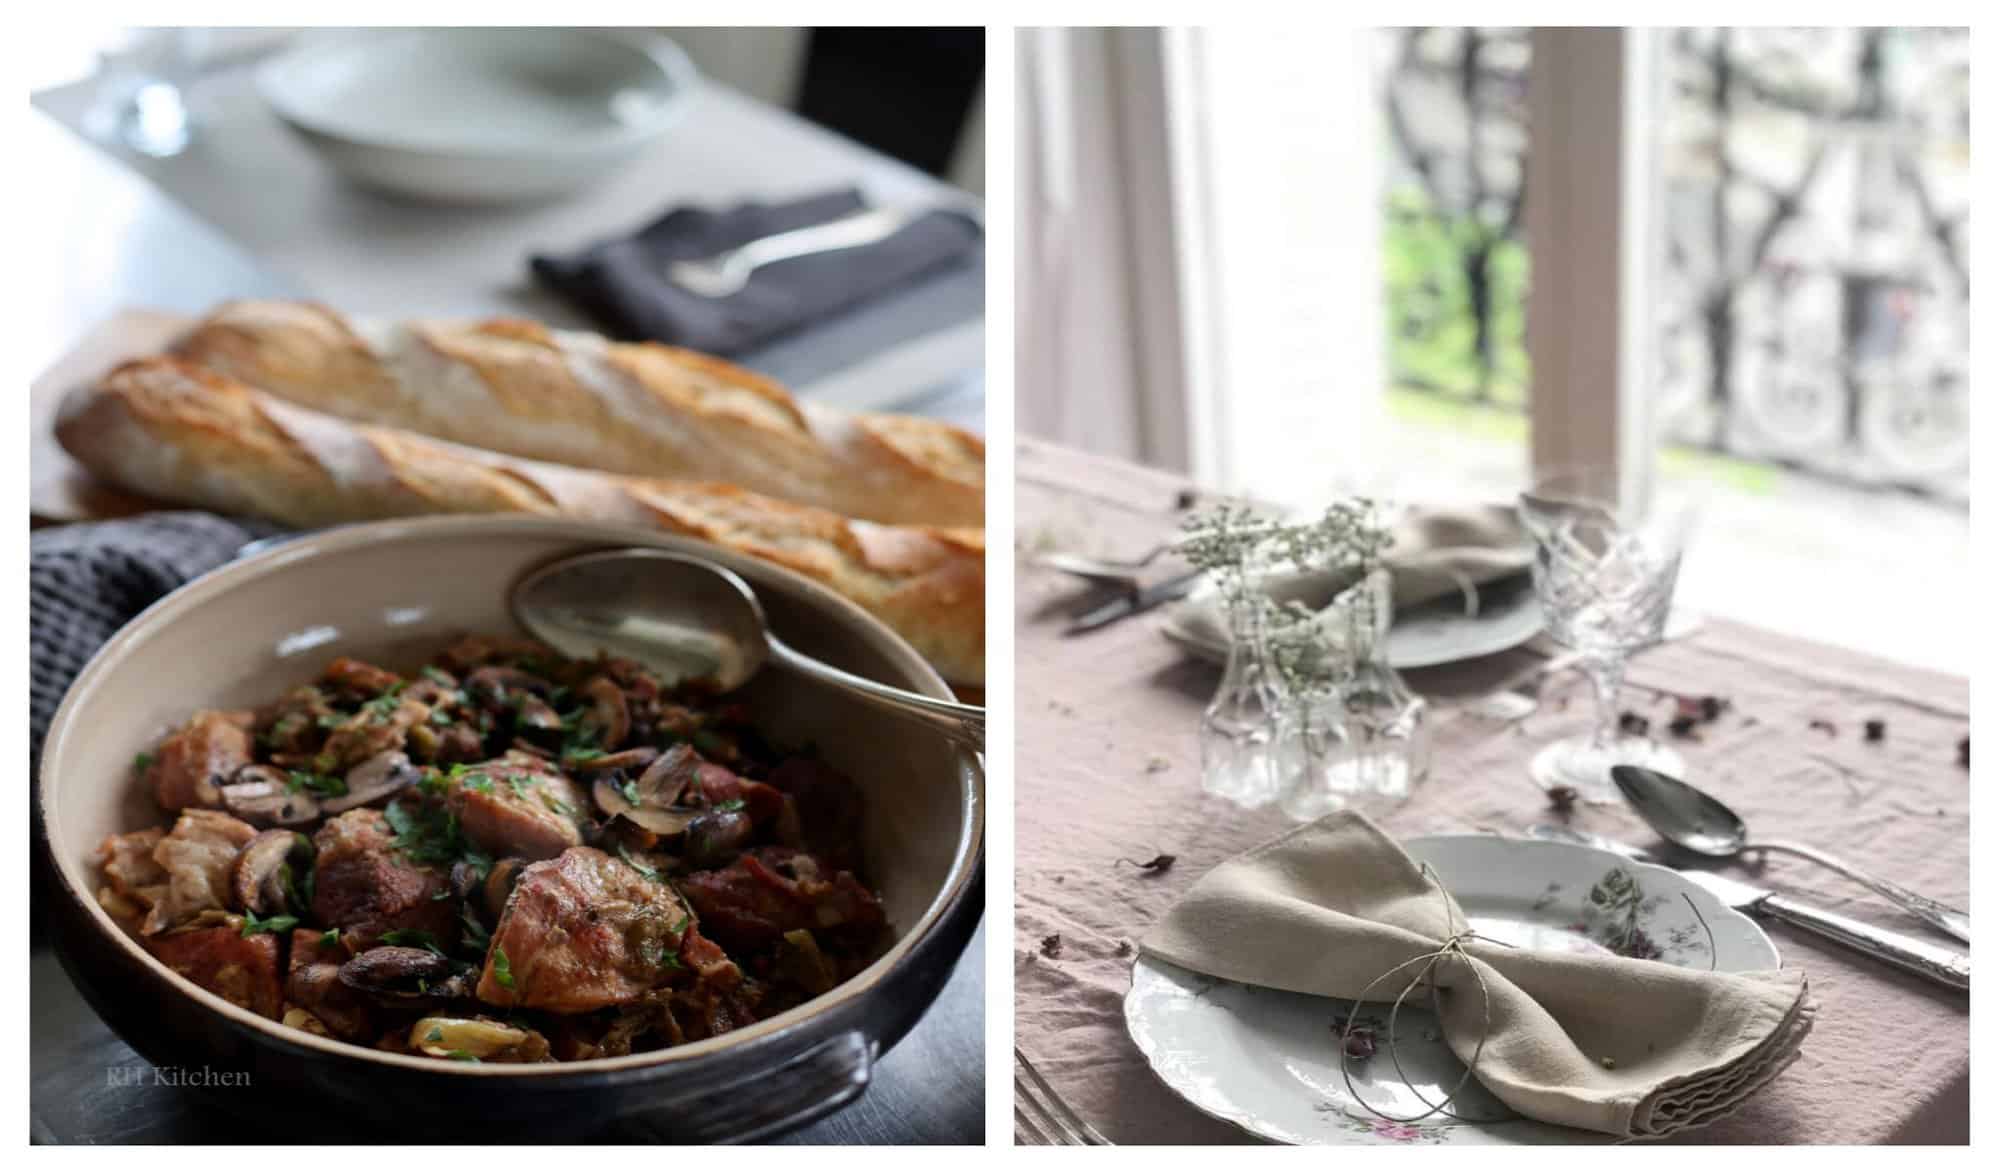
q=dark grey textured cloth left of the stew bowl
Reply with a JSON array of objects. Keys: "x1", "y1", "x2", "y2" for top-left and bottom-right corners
[{"x1": 28, "y1": 512, "x2": 282, "y2": 768}]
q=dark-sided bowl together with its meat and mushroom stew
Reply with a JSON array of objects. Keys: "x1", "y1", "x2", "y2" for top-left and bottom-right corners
[{"x1": 38, "y1": 518, "x2": 984, "y2": 1140}]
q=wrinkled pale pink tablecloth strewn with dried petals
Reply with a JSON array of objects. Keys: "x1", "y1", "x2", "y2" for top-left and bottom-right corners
[{"x1": 1014, "y1": 440, "x2": 1972, "y2": 1144}]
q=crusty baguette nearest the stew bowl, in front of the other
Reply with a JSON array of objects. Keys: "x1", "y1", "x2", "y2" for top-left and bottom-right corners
[{"x1": 56, "y1": 358, "x2": 986, "y2": 684}]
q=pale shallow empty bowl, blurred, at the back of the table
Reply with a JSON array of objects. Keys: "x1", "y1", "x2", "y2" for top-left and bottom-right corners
[{"x1": 256, "y1": 28, "x2": 696, "y2": 204}]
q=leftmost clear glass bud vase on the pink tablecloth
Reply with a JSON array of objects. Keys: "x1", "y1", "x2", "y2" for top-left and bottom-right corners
[{"x1": 1200, "y1": 590, "x2": 1280, "y2": 808}]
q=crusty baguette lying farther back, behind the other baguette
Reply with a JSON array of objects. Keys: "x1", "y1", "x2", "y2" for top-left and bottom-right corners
[{"x1": 174, "y1": 302, "x2": 986, "y2": 526}]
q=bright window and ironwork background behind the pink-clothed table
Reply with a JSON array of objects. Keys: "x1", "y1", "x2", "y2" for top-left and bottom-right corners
[{"x1": 1016, "y1": 28, "x2": 1970, "y2": 672}]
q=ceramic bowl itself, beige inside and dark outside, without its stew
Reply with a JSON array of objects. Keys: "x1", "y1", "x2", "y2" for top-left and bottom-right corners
[{"x1": 36, "y1": 516, "x2": 984, "y2": 1140}]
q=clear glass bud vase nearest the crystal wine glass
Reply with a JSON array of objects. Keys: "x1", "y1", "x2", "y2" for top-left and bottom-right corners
[{"x1": 1278, "y1": 570, "x2": 1430, "y2": 822}]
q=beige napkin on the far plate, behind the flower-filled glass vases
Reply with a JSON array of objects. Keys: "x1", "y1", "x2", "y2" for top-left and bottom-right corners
[{"x1": 1166, "y1": 504, "x2": 1534, "y2": 650}]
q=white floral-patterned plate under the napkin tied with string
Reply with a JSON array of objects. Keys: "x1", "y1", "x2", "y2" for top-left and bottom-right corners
[{"x1": 1126, "y1": 834, "x2": 1778, "y2": 1144}]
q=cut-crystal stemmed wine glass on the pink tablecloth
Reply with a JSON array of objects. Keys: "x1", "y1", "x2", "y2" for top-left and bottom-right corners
[{"x1": 1520, "y1": 470, "x2": 1692, "y2": 802}]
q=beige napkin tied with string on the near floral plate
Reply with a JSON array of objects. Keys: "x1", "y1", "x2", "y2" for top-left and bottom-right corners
[{"x1": 1140, "y1": 812, "x2": 1812, "y2": 1138}]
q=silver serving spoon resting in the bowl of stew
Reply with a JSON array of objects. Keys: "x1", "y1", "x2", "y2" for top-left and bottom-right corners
[{"x1": 508, "y1": 548, "x2": 986, "y2": 752}]
